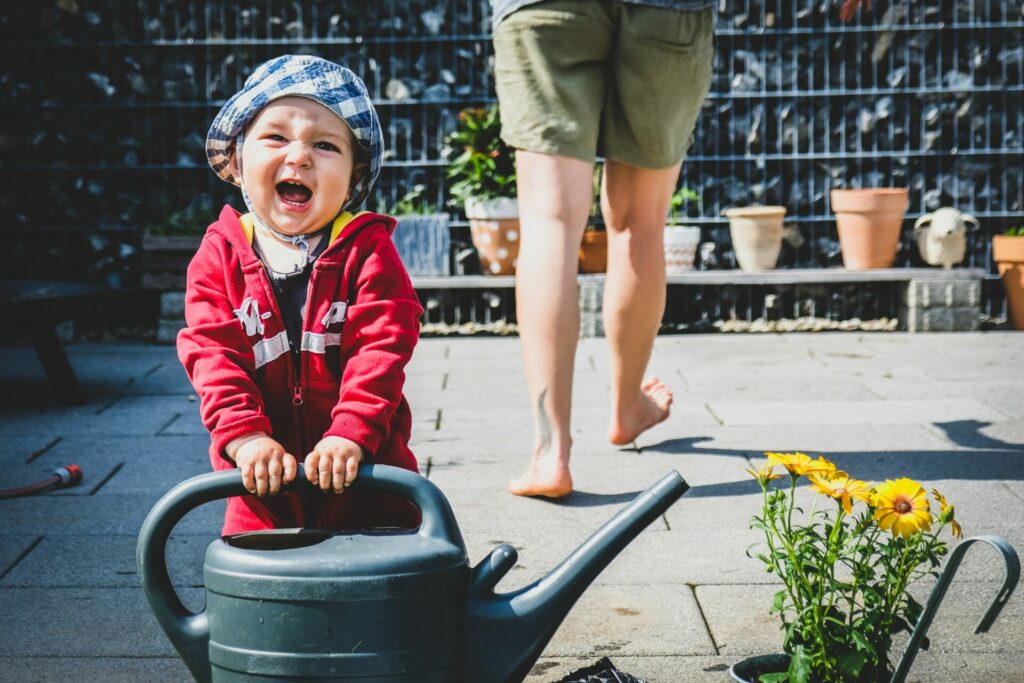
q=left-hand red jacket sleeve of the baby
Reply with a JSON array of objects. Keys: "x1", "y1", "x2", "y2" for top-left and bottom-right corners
[{"x1": 177, "y1": 238, "x2": 271, "y2": 462}]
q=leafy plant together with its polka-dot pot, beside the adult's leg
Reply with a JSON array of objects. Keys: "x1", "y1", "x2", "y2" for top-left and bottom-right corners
[{"x1": 445, "y1": 104, "x2": 519, "y2": 275}]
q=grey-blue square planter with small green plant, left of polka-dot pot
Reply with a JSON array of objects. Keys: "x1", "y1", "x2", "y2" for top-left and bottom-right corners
[{"x1": 388, "y1": 184, "x2": 452, "y2": 275}]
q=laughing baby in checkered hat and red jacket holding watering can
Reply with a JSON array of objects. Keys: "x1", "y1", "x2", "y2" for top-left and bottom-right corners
[{"x1": 177, "y1": 55, "x2": 423, "y2": 535}]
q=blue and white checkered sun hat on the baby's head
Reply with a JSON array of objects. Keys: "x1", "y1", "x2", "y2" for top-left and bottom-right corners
[{"x1": 206, "y1": 54, "x2": 384, "y2": 210}]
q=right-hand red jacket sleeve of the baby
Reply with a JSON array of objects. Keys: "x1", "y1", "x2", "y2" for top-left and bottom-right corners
[{"x1": 325, "y1": 227, "x2": 423, "y2": 457}]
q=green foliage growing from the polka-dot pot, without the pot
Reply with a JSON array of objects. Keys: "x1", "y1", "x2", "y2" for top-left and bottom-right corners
[{"x1": 444, "y1": 104, "x2": 516, "y2": 207}]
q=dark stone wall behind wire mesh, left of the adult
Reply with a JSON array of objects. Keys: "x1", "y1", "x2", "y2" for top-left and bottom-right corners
[{"x1": 0, "y1": 0, "x2": 494, "y2": 286}]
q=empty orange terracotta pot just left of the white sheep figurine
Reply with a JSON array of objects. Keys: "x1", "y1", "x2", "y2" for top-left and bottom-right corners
[{"x1": 831, "y1": 187, "x2": 910, "y2": 270}]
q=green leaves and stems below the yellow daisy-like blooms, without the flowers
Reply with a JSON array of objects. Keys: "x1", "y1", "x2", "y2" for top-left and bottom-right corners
[{"x1": 746, "y1": 466, "x2": 947, "y2": 683}]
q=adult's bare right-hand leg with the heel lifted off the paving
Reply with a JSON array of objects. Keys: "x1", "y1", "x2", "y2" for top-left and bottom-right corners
[{"x1": 601, "y1": 160, "x2": 681, "y2": 444}]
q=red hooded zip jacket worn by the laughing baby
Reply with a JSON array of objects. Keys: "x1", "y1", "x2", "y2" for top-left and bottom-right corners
[{"x1": 177, "y1": 206, "x2": 423, "y2": 535}]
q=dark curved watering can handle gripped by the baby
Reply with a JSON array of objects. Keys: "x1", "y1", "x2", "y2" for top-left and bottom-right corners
[{"x1": 135, "y1": 465, "x2": 465, "y2": 681}]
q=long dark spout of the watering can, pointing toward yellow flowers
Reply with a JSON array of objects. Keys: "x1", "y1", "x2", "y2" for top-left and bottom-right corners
[{"x1": 465, "y1": 470, "x2": 689, "y2": 683}]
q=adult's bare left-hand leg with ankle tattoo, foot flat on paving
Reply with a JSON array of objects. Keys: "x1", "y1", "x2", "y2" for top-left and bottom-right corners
[{"x1": 509, "y1": 150, "x2": 598, "y2": 498}]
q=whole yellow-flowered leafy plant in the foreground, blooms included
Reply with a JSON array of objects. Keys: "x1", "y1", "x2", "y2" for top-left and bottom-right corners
[{"x1": 748, "y1": 453, "x2": 963, "y2": 683}]
